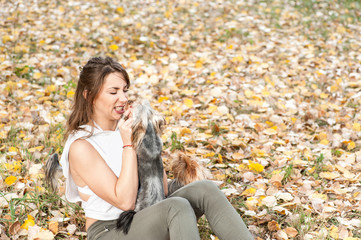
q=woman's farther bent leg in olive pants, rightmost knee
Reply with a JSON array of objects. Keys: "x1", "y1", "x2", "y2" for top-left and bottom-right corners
[{"x1": 169, "y1": 180, "x2": 254, "y2": 240}]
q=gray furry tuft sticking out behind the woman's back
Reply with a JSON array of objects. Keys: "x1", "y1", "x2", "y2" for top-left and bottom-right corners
[{"x1": 45, "y1": 153, "x2": 61, "y2": 192}]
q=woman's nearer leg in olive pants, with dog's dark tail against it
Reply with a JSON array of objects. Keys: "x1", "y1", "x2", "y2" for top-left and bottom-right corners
[{"x1": 88, "y1": 197, "x2": 200, "y2": 240}]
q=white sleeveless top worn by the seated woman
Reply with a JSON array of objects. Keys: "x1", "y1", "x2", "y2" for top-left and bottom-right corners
[{"x1": 60, "y1": 125, "x2": 123, "y2": 220}]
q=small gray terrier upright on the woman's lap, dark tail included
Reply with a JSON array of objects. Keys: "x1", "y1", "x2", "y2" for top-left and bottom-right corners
[{"x1": 117, "y1": 102, "x2": 165, "y2": 234}]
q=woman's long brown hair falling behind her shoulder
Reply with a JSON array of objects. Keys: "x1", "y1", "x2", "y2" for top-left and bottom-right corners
[{"x1": 65, "y1": 57, "x2": 130, "y2": 139}]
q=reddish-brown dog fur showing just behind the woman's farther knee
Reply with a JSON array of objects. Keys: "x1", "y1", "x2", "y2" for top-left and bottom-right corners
[{"x1": 168, "y1": 152, "x2": 211, "y2": 195}]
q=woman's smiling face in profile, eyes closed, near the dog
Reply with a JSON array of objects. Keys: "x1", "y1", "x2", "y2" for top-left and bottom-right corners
[{"x1": 93, "y1": 72, "x2": 128, "y2": 130}]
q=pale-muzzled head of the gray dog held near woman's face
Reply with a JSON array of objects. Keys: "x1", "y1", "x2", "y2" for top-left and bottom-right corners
[{"x1": 132, "y1": 100, "x2": 166, "y2": 149}]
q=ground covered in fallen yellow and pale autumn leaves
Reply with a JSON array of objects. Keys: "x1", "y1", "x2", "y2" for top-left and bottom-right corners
[{"x1": 0, "y1": 0, "x2": 361, "y2": 239}]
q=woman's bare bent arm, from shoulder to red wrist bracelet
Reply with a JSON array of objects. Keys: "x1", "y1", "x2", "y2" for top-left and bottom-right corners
[{"x1": 69, "y1": 139, "x2": 138, "y2": 211}]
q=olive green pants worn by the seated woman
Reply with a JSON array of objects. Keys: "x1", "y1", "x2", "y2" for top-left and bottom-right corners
[{"x1": 88, "y1": 181, "x2": 253, "y2": 240}]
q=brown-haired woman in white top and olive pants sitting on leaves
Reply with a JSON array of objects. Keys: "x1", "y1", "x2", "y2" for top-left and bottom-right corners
[{"x1": 60, "y1": 57, "x2": 253, "y2": 240}]
